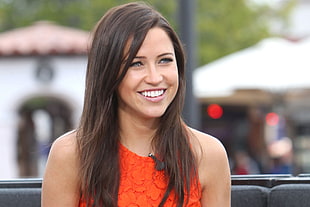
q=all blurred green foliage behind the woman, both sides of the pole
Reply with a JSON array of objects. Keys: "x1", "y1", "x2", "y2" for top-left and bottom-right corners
[{"x1": 0, "y1": 0, "x2": 294, "y2": 65}]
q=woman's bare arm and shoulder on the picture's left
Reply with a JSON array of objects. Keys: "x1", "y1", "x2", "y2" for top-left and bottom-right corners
[{"x1": 41, "y1": 132, "x2": 80, "y2": 207}]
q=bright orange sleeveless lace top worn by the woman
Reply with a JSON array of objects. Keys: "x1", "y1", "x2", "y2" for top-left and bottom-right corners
[{"x1": 79, "y1": 145, "x2": 201, "y2": 207}]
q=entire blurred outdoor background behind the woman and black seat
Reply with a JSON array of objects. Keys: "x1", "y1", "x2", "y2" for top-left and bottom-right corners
[{"x1": 0, "y1": 0, "x2": 310, "y2": 179}]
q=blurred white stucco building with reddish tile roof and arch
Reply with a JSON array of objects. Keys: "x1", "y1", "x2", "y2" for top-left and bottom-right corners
[{"x1": 0, "y1": 22, "x2": 90, "y2": 179}]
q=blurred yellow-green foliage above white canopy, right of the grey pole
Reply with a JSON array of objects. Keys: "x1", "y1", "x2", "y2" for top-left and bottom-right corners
[{"x1": 197, "y1": 0, "x2": 295, "y2": 65}]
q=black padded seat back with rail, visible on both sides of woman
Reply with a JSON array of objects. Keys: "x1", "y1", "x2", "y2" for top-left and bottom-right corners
[{"x1": 0, "y1": 174, "x2": 310, "y2": 207}]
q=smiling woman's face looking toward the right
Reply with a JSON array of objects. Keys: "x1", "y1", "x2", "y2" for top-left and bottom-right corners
[{"x1": 118, "y1": 27, "x2": 178, "y2": 119}]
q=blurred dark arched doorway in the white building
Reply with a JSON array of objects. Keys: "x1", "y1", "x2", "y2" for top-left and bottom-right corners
[{"x1": 16, "y1": 96, "x2": 73, "y2": 177}]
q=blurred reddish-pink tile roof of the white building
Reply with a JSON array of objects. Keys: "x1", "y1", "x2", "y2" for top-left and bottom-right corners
[{"x1": 0, "y1": 21, "x2": 90, "y2": 56}]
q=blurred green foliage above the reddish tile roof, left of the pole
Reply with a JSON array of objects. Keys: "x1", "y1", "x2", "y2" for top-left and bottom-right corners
[{"x1": 0, "y1": 0, "x2": 175, "y2": 32}]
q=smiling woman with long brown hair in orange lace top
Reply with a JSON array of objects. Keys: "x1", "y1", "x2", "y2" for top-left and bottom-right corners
[{"x1": 42, "y1": 3, "x2": 230, "y2": 207}]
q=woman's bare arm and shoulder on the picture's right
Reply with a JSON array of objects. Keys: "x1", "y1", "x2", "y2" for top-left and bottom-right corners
[{"x1": 193, "y1": 130, "x2": 231, "y2": 207}]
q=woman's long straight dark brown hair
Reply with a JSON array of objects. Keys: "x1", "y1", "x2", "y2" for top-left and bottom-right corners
[{"x1": 77, "y1": 3, "x2": 197, "y2": 206}]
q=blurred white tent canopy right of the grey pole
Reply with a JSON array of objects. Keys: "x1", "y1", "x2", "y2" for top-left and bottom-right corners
[{"x1": 193, "y1": 38, "x2": 310, "y2": 98}]
